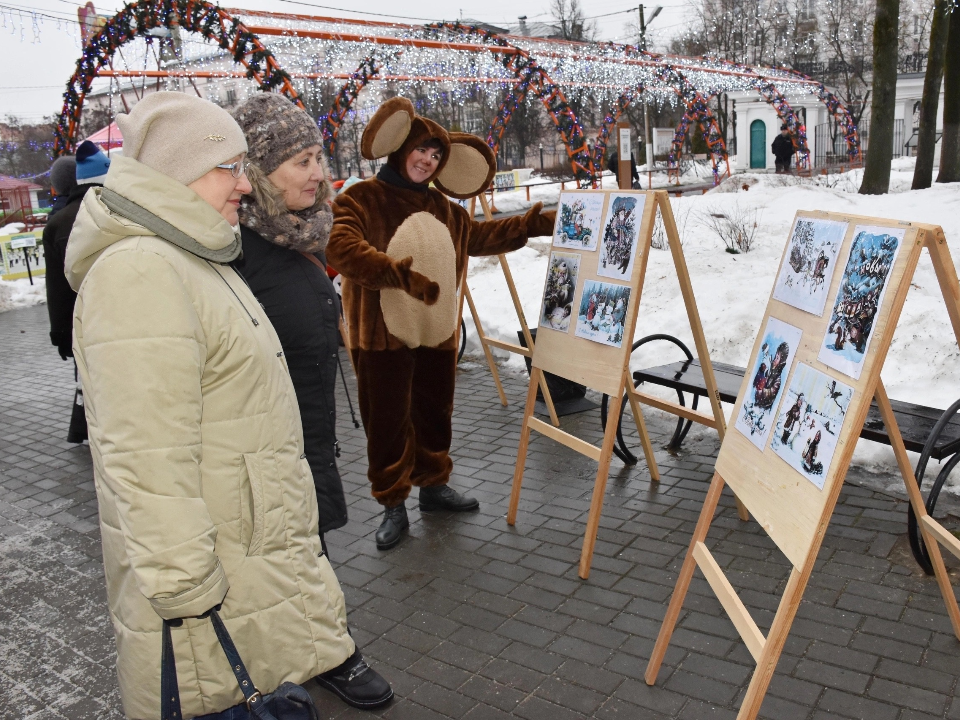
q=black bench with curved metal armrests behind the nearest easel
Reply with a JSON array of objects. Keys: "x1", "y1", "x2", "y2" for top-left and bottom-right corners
[{"x1": 601, "y1": 335, "x2": 960, "y2": 574}]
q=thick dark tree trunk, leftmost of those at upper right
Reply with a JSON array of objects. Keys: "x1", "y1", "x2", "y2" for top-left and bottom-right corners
[{"x1": 860, "y1": 0, "x2": 900, "y2": 195}]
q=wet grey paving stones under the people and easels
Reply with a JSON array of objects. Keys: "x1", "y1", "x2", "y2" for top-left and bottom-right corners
[{"x1": 0, "y1": 306, "x2": 960, "y2": 720}]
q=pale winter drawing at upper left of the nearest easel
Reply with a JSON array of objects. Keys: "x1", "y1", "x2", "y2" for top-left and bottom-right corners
[{"x1": 773, "y1": 218, "x2": 849, "y2": 317}]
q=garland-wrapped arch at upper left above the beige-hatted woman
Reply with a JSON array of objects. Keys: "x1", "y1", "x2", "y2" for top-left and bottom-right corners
[{"x1": 54, "y1": 0, "x2": 302, "y2": 156}]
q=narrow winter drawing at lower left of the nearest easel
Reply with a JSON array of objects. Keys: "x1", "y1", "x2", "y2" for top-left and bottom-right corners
[{"x1": 736, "y1": 318, "x2": 803, "y2": 450}]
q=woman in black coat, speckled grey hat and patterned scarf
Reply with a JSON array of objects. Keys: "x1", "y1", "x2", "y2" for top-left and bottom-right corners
[{"x1": 235, "y1": 93, "x2": 347, "y2": 550}]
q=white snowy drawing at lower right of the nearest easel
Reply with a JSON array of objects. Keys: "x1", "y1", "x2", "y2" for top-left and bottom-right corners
[{"x1": 771, "y1": 363, "x2": 853, "y2": 490}]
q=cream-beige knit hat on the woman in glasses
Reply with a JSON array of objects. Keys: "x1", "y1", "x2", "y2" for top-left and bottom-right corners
[{"x1": 117, "y1": 92, "x2": 247, "y2": 185}]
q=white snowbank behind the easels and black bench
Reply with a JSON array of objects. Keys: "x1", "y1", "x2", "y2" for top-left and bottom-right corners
[{"x1": 465, "y1": 158, "x2": 960, "y2": 493}]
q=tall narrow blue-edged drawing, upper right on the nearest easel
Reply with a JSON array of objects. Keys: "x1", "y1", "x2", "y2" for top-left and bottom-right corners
[{"x1": 817, "y1": 226, "x2": 906, "y2": 379}]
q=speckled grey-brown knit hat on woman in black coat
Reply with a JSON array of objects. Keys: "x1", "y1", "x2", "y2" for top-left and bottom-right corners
[{"x1": 233, "y1": 92, "x2": 323, "y2": 175}]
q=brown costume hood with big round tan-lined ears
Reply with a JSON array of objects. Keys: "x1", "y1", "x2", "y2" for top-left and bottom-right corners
[{"x1": 360, "y1": 97, "x2": 497, "y2": 200}]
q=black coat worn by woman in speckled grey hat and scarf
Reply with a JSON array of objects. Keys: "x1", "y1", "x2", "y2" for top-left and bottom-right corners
[{"x1": 235, "y1": 227, "x2": 347, "y2": 534}]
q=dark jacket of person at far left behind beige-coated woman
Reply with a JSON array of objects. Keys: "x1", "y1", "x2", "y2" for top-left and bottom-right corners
[{"x1": 43, "y1": 185, "x2": 99, "y2": 359}]
